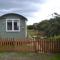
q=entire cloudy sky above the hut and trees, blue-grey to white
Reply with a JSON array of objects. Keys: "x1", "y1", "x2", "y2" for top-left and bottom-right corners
[{"x1": 0, "y1": 0, "x2": 60, "y2": 25}]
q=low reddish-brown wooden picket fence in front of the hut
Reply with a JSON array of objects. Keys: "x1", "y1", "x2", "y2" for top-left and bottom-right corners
[{"x1": 0, "y1": 38, "x2": 60, "y2": 53}]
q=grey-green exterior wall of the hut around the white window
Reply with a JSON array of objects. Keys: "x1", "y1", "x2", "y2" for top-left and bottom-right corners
[{"x1": 0, "y1": 15, "x2": 26, "y2": 39}]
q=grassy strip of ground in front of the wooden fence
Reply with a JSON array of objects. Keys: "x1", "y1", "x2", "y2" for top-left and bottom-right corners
[{"x1": 0, "y1": 52, "x2": 60, "y2": 60}]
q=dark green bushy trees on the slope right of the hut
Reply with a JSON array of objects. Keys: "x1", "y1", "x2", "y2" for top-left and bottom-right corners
[{"x1": 27, "y1": 13, "x2": 60, "y2": 37}]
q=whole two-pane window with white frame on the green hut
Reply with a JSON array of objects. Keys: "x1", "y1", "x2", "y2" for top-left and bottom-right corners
[{"x1": 6, "y1": 19, "x2": 20, "y2": 32}]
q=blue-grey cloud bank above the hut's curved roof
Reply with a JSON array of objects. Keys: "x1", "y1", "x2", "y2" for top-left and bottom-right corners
[{"x1": 0, "y1": 0, "x2": 44, "y2": 16}]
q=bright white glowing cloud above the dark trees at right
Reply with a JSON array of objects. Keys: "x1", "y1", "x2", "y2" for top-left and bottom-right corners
[{"x1": 28, "y1": 0, "x2": 60, "y2": 24}]
